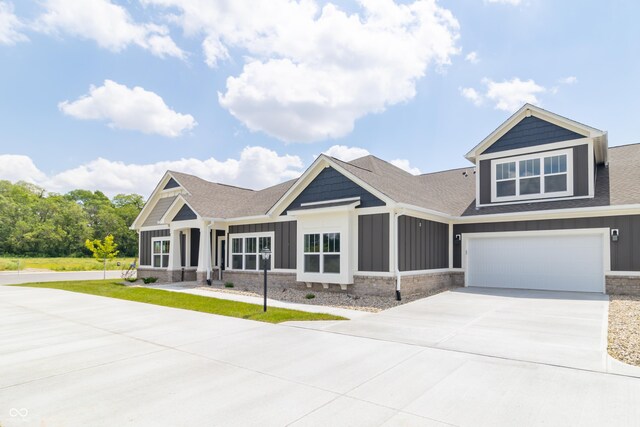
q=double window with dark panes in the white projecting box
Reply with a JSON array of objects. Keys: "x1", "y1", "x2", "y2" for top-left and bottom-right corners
[{"x1": 304, "y1": 233, "x2": 340, "y2": 274}]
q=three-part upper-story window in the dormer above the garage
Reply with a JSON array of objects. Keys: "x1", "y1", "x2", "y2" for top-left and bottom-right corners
[{"x1": 492, "y1": 150, "x2": 573, "y2": 202}]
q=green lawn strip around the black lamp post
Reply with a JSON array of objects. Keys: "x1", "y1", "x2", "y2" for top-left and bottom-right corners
[{"x1": 13, "y1": 280, "x2": 346, "y2": 323}]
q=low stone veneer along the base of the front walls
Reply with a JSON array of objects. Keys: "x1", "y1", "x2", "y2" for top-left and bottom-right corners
[{"x1": 222, "y1": 271, "x2": 464, "y2": 298}]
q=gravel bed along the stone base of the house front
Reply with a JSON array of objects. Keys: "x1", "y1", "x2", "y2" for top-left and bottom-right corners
[{"x1": 199, "y1": 286, "x2": 454, "y2": 313}]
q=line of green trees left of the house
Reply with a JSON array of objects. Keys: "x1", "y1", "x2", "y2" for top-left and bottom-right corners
[{"x1": 0, "y1": 181, "x2": 144, "y2": 257}]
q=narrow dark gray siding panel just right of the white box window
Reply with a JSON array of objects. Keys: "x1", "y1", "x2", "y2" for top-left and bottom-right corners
[{"x1": 358, "y1": 213, "x2": 389, "y2": 271}]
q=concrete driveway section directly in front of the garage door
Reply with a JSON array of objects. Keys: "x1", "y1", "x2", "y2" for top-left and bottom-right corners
[{"x1": 300, "y1": 288, "x2": 609, "y2": 371}]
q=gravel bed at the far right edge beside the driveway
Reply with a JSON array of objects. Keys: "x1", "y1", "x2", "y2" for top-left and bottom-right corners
[{"x1": 609, "y1": 295, "x2": 640, "y2": 366}]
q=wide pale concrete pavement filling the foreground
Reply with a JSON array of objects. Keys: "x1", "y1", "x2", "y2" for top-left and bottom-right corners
[{"x1": 0, "y1": 286, "x2": 640, "y2": 427}]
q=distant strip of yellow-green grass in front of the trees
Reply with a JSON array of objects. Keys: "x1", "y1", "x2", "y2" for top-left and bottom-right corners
[{"x1": 0, "y1": 258, "x2": 134, "y2": 271}]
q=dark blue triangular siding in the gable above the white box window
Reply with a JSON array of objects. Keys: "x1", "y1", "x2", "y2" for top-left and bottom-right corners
[{"x1": 284, "y1": 167, "x2": 385, "y2": 214}]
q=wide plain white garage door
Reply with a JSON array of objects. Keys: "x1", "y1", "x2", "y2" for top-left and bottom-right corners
[{"x1": 465, "y1": 232, "x2": 604, "y2": 292}]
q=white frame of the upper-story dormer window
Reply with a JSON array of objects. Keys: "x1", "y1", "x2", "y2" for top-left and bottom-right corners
[{"x1": 491, "y1": 148, "x2": 573, "y2": 202}]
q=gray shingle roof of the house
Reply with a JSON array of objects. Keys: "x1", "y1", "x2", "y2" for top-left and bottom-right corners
[{"x1": 166, "y1": 144, "x2": 640, "y2": 222}]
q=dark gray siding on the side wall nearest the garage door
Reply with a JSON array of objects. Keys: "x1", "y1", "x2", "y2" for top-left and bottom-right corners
[{"x1": 398, "y1": 215, "x2": 449, "y2": 271}]
